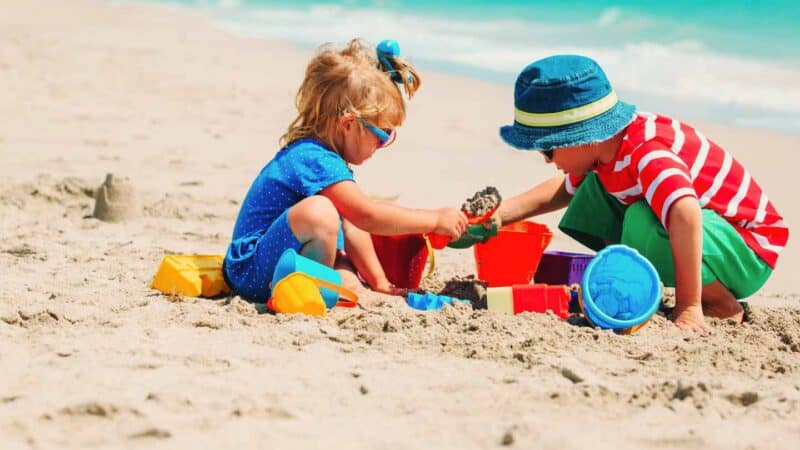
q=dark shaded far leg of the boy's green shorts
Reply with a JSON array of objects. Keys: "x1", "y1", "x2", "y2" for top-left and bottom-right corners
[{"x1": 558, "y1": 172, "x2": 625, "y2": 251}]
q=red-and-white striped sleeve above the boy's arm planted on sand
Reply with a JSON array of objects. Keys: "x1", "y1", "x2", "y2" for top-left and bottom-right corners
[{"x1": 631, "y1": 142, "x2": 697, "y2": 228}]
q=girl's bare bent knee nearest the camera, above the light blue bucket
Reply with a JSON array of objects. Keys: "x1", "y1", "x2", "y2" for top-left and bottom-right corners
[{"x1": 288, "y1": 195, "x2": 341, "y2": 267}]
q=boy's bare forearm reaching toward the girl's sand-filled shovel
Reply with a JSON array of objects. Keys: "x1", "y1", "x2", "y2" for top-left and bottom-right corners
[{"x1": 495, "y1": 175, "x2": 572, "y2": 225}]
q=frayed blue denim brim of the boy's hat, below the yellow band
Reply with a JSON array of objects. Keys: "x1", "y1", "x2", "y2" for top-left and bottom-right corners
[{"x1": 500, "y1": 102, "x2": 636, "y2": 151}]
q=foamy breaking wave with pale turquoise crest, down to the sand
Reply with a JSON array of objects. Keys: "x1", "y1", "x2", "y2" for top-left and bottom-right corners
[{"x1": 141, "y1": 0, "x2": 800, "y2": 131}]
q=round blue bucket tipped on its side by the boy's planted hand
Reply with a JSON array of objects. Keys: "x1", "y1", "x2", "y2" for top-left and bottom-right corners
[{"x1": 581, "y1": 245, "x2": 661, "y2": 333}]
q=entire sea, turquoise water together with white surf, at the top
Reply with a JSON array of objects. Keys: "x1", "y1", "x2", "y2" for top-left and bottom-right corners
[{"x1": 139, "y1": 0, "x2": 800, "y2": 132}]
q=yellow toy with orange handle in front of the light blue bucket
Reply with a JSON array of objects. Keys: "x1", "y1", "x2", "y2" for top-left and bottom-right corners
[{"x1": 268, "y1": 272, "x2": 358, "y2": 316}]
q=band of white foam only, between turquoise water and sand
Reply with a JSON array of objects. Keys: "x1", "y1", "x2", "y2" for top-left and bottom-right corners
[{"x1": 212, "y1": 0, "x2": 800, "y2": 123}]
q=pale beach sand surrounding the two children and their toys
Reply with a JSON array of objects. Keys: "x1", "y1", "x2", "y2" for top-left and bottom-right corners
[{"x1": 0, "y1": 0, "x2": 800, "y2": 450}]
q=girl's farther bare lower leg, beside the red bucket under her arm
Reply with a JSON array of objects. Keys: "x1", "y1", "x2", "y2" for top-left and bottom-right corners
[{"x1": 343, "y1": 220, "x2": 404, "y2": 295}]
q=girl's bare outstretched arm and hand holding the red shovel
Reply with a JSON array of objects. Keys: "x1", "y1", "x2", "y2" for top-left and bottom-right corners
[{"x1": 320, "y1": 181, "x2": 467, "y2": 239}]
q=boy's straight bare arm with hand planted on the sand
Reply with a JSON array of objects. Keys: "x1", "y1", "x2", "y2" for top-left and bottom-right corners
[{"x1": 668, "y1": 197, "x2": 708, "y2": 331}]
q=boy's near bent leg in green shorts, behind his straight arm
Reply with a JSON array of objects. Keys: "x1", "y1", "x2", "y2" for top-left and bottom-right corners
[{"x1": 621, "y1": 201, "x2": 772, "y2": 319}]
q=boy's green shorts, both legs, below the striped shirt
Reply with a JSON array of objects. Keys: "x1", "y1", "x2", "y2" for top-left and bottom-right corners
[{"x1": 558, "y1": 173, "x2": 772, "y2": 299}]
